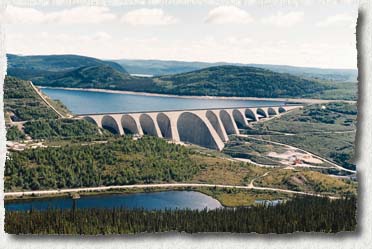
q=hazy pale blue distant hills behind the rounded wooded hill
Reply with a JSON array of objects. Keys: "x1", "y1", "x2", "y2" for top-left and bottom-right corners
[{"x1": 115, "y1": 59, "x2": 358, "y2": 82}]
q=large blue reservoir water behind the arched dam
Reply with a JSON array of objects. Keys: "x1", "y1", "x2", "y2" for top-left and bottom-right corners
[{"x1": 41, "y1": 87, "x2": 284, "y2": 114}]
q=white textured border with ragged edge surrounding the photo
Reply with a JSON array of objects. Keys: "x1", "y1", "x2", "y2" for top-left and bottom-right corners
[{"x1": 0, "y1": 0, "x2": 372, "y2": 249}]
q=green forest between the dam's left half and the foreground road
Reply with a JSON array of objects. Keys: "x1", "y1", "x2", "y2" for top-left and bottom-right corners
[{"x1": 5, "y1": 137, "x2": 207, "y2": 191}]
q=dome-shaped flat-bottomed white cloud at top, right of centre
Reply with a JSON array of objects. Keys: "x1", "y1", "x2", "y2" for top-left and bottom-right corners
[{"x1": 205, "y1": 6, "x2": 253, "y2": 24}]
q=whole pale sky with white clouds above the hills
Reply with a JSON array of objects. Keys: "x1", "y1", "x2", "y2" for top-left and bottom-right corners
[{"x1": 0, "y1": 2, "x2": 358, "y2": 69}]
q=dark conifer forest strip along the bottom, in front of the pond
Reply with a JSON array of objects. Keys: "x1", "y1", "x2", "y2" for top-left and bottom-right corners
[{"x1": 5, "y1": 197, "x2": 356, "y2": 235}]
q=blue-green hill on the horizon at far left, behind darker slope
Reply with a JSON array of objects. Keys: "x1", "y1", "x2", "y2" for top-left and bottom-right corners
[{"x1": 7, "y1": 54, "x2": 127, "y2": 80}]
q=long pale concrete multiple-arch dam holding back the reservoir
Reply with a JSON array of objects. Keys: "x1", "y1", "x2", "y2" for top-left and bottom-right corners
[{"x1": 75, "y1": 105, "x2": 302, "y2": 150}]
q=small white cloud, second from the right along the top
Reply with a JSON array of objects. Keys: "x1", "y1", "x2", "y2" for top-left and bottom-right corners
[{"x1": 262, "y1": 11, "x2": 304, "y2": 27}]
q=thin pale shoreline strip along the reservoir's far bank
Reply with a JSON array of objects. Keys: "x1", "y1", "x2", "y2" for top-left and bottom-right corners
[{"x1": 37, "y1": 86, "x2": 348, "y2": 104}]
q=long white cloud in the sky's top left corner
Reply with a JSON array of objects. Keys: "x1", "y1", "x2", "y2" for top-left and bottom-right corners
[{"x1": 0, "y1": 6, "x2": 116, "y2": 24}]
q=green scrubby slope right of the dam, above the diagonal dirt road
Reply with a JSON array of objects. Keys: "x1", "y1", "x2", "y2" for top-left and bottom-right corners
[{"x1": 247, "y1": 103, "x2": 357, "y2": 169}]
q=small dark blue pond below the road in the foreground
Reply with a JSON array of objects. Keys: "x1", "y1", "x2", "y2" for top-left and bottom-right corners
[{"x1": 5, "y1": 191, "x2": 222, "y2": 211}]
